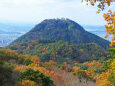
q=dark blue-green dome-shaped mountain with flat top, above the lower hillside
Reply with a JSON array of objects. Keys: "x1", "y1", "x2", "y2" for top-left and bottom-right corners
[{"x1": 13, "y1": 19, "x2": 109, "y2": 48}]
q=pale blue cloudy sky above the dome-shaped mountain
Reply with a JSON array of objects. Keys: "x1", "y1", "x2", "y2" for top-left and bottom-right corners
[{"x1": 0, "y1": 0, "x2": 115, "y2": 25}]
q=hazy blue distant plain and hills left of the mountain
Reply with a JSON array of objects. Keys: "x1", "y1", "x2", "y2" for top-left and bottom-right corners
[{"x1": 0, "y1": 22, "x2": 34, "y2": 47}]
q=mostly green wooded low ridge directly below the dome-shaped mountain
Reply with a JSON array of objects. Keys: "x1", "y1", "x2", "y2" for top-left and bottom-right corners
[{"x1": 9, "y1": 40, "x2": 108, "y2": 63}]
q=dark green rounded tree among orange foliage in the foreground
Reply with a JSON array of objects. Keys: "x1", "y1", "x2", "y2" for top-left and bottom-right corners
[{"x1": 19, "y1": 68, "x2": 53, "y2": 86}]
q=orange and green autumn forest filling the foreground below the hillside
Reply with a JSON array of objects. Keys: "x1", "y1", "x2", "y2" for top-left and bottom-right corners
[{"x1": 0, "y1": 48, "x2": 115, "y2": 86}]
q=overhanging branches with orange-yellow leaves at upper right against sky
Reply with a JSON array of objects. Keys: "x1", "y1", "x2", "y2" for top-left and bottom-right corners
[{"x1": 82, "y1": 0, "x2": 115, "y2": 47}]
